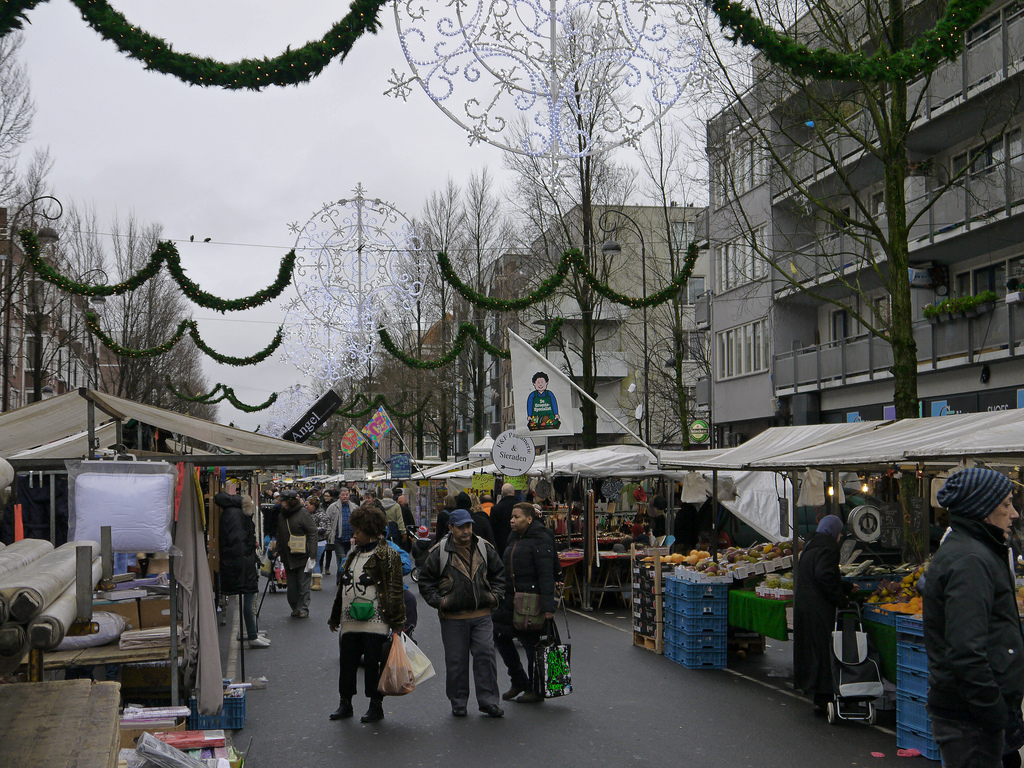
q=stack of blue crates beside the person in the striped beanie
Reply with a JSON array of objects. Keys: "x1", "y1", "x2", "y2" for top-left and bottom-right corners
[{"x1": 896, "y1": 615, "x2": 939, "y2": 760}]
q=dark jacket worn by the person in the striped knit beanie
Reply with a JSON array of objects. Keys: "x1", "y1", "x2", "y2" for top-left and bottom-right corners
[{"x1": 924, "y1": 516, "x2": 1024, "y2": 730}]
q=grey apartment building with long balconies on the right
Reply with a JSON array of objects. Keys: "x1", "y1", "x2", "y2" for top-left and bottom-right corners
[{"x1": 697, "y1": 2, "x2": 1024, "y2": 445}]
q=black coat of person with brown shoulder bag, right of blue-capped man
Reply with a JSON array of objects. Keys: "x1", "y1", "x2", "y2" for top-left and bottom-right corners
[{"x1": 494, "y1": 520, "x2": 561, "y2": 633}]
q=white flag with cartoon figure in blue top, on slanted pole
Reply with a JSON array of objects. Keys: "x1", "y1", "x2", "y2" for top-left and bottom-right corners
[{"x1": 509, "y1": 331, "x2": 579, "y2": 437}]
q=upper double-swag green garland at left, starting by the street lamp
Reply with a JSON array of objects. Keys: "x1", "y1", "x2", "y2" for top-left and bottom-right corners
[{"x1": 18, "y1": 229, "x2": 295, "y2": 312}]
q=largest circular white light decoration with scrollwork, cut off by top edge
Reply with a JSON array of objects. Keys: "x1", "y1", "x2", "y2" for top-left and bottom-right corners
[{"x1": 385, "y1": 0, "x2": 708, "y2": 162}]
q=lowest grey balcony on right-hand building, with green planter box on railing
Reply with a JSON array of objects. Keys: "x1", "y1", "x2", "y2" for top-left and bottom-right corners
[{"x1": 772, "y1": 302, "x2": 1024, "y2": 396}]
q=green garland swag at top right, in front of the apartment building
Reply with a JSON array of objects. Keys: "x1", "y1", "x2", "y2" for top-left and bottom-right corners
[{"x1": 711, "y1": 0, "x2": 989, "y2": 82}]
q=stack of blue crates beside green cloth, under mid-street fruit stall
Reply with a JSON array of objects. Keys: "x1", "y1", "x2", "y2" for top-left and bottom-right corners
[{"x1": 665, "y1": 577, "x2": 729, "y2": 670}]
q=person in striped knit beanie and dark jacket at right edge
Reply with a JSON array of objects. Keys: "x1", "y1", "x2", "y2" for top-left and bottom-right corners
[{"x1": 924, "y1": 467, "x2": 1024, "y2": 768}]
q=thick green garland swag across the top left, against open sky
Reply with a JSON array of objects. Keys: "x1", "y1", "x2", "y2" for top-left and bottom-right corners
[{"x1": 64, "y1": 0, "x2": 386, "y2": 90}]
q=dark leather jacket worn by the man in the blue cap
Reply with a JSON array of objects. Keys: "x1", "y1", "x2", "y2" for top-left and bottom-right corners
[{"x1": 420, "y1": 534, "x2": 505, "y2": 618}]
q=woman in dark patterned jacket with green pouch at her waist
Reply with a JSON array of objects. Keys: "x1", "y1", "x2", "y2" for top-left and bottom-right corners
[{"x1": 327, "y1": 504, "x2": 406, "y2": 723}]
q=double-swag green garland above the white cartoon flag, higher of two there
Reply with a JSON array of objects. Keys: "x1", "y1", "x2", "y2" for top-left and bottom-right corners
[{"x1": 437, "y1": 243, "x2": 697, "y2": 311}]
